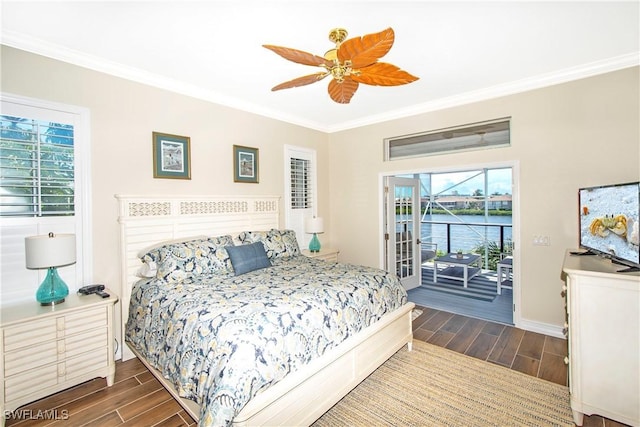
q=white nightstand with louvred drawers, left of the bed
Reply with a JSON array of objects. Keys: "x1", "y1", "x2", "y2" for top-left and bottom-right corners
[{"x1": 0, "y1": 290, "x2": 118, "y2": 414}]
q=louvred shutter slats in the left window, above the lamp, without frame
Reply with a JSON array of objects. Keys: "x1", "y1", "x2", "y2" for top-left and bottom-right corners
[{"x1": 0, "y1": 115, "x2": 75, "y2": 217}]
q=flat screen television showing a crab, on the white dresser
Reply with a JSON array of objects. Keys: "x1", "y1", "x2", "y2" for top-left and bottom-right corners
[{"x1": 578, "y1": 182, "x2": 640, "y2": 271}]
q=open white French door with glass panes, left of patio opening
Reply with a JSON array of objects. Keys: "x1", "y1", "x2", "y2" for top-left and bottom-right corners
[{"x1": 385, "y1": 177, "x2": 422, "y2": 290}]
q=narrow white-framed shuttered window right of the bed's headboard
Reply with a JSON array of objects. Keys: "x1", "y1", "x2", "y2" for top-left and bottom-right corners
[{"x1": 284, "y1": 146, "x2": 318, "y2": 249}]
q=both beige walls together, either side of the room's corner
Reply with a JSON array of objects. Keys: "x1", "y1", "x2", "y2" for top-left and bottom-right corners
[{"x1": 1, "y1": 46, "x2": 640, "y2": 332}]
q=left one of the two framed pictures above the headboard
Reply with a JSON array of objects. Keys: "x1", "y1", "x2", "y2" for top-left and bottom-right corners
[{"x1": 153, "y1": 132, "x2": 191, "y2": 179}]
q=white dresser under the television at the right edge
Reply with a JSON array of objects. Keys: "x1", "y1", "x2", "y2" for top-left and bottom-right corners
[{"x1": 563, "y1": 252, "x2": 640, "y2": 426}]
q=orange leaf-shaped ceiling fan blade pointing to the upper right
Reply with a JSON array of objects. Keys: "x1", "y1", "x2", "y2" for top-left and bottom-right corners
[{"x1": 338, "y1": 28, "x2": 395, "y2": 69}]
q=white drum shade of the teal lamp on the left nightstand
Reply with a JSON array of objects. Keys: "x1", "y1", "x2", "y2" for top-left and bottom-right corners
[{"x1": 24, "y1": 233, "x2": 76, "y2": 268}]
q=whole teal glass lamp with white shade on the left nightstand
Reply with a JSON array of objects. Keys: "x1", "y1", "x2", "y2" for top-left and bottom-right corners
[{"x1": 24, "y1": 233, "x2": 76, "y2": 305}]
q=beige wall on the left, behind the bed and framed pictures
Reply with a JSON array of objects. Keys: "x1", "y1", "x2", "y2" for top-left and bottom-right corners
[{"x1": 1, "y1": 46, "x2": 330, "y2": 312}]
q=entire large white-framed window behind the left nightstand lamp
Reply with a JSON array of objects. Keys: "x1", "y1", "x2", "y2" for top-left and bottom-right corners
[{"x1": 0, "y1": 93, "x2": 92, "y2": 304}]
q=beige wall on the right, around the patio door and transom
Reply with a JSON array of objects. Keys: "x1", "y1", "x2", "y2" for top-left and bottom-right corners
[{"x1": 330, "y1": 67, "x2": 640, "y2": 326}]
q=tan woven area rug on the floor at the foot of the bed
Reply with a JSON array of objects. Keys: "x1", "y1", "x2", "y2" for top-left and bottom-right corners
[{"x1": 313, "y1": 340, "x2": 574, "y2": 427}]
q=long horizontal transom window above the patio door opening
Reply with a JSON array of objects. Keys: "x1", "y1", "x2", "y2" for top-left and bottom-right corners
[{"x1": 384, "y1": 119, "x2": 511, "y2": 160}]
